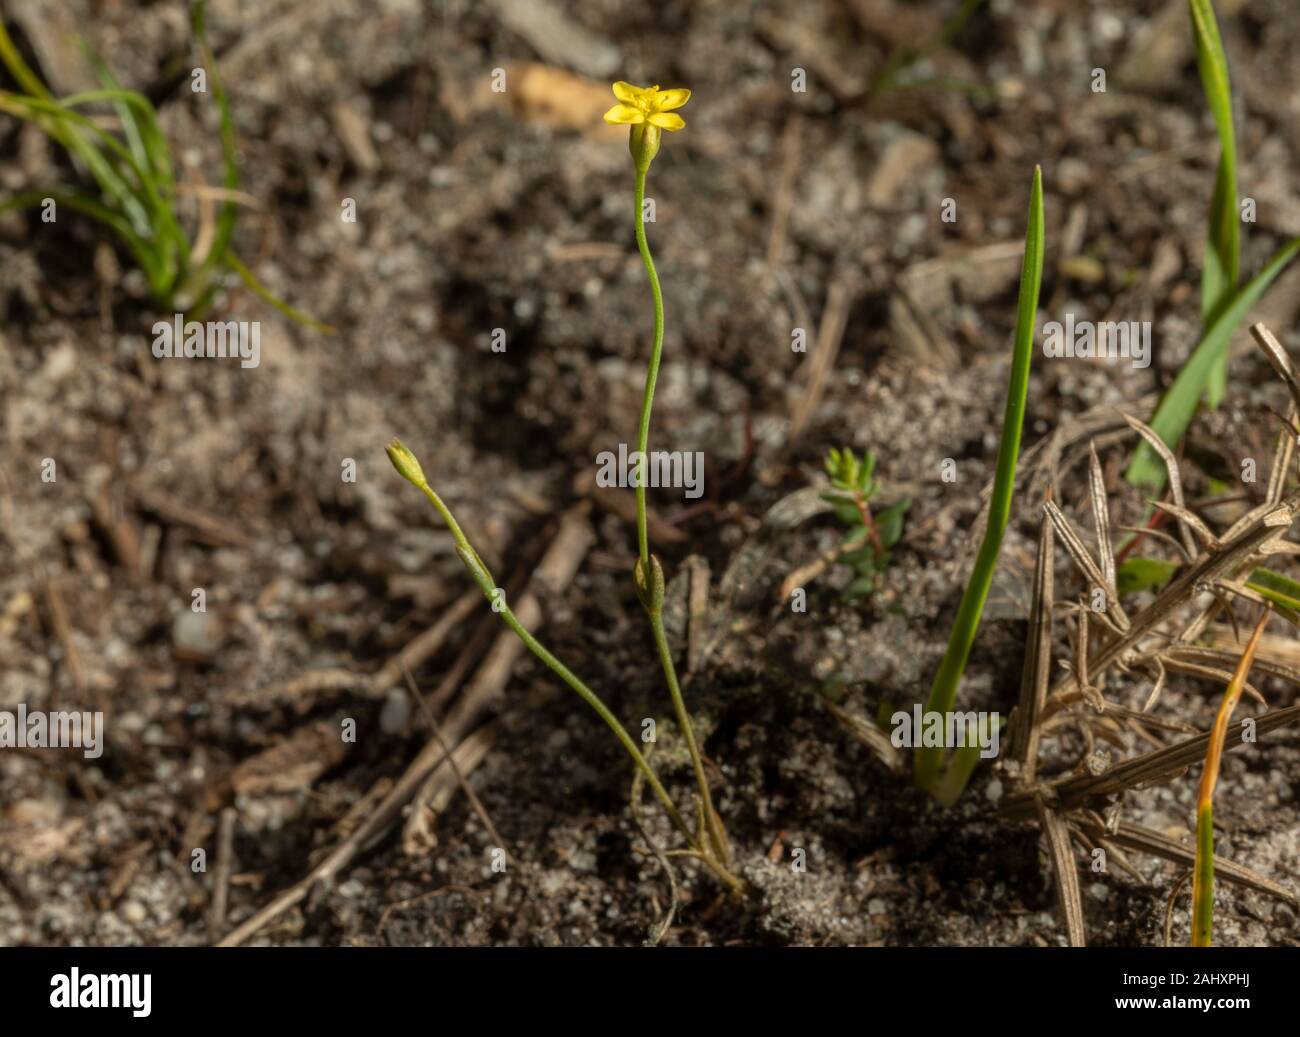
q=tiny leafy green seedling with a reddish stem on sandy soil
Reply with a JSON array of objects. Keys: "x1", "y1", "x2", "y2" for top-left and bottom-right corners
[{"x1": 822, "y1": 447, "x2": 911, "y2": 599}]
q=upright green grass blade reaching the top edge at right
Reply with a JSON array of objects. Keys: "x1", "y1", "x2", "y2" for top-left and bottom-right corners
[{"x1": 1188, "y1": 0, "x2": 1242, "y2": 408}]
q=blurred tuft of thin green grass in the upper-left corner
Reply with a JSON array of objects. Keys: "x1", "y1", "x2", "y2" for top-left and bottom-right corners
[{"x1": 0, "y1": 0, "x2": 333, "y2": 333}]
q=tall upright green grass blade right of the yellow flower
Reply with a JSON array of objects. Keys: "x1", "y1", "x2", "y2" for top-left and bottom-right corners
[{"x1": 914, "y1": 166, "x2": 1043, "y2": 789}]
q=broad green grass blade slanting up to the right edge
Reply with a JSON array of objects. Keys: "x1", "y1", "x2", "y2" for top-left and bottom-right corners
[{"x1": 1125, "y1": 238, "x2": 1300, "y2": 494}]
